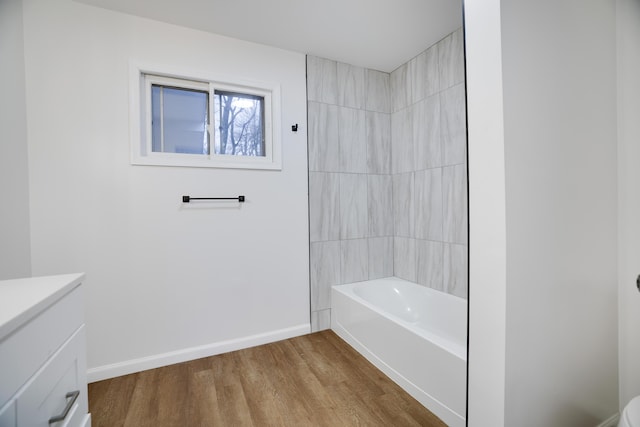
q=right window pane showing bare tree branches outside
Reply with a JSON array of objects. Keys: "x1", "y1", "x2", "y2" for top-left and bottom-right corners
[{"x1": 214, "y1": 90, "x2": 265, "y2": 157}]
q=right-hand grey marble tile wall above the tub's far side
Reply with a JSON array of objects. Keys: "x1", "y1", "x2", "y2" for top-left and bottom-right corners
[{"x1": 390, "y1": 29, "x2": 468, "y2": 298}]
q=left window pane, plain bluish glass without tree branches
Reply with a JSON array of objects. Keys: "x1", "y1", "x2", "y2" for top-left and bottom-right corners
[{"x1": 151, "y1": 84, "x2": 209, "y2": 154}]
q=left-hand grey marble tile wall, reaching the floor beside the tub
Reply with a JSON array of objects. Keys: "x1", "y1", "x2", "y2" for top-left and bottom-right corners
[{"x1": 307, "y1": 56, "x2": 394, "y2": 331}]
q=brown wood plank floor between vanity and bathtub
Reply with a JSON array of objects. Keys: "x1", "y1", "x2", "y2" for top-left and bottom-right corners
[{"x1": 89, "y1": 331, "x2": 445, "y2": 427}]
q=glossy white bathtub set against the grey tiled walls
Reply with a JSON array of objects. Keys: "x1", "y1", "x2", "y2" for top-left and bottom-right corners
[{"x1": 331, "y1": 277, "x2": 467, "y2": 427}]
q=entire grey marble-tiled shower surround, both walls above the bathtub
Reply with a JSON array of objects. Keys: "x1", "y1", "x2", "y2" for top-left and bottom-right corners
[{"x1": 307, "y1": 29, "x2": 467, "y2": 331}]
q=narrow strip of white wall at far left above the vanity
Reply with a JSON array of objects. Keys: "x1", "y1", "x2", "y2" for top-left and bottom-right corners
[{"x1": 0, "y1": 0, "x2": 31, "y2": 280}]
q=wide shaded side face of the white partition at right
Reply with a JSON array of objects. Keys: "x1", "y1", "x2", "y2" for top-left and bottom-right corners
[{"x1": 501, "y1": 0, "x2": 618, "y2": 427}]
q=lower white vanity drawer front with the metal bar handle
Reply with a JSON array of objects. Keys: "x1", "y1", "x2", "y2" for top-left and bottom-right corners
[{"x1": 15, "y1": 325, "x2": 88, "y2": 427}]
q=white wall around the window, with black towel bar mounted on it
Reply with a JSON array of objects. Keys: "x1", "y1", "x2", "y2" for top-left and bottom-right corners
[{"x1": 24, "y1": 0, "x2": 309, "y2": 380}]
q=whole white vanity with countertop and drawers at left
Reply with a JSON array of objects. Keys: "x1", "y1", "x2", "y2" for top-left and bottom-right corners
[{"x1": 0, "y1": 274, "x2": 91, "y2": 427}]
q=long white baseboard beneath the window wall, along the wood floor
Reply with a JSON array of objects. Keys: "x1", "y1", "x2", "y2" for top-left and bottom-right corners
[{"x1": 87, "y1": 323, "x2": 311, "y2": 383}]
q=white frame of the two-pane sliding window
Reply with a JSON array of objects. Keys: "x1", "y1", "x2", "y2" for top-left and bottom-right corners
[{"x1": 130, "y1": 65, "x2": 282, "y2": 170}]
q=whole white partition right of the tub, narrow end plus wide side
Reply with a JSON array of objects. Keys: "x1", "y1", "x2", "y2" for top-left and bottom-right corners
[{"x1": 465, "y1": 0, "x2": 618, "y2": 427}]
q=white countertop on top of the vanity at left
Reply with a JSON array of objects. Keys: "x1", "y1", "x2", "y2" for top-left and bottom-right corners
[{"x1": 0, "y1": 273, "x2": 84, "y2": 341}]
